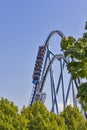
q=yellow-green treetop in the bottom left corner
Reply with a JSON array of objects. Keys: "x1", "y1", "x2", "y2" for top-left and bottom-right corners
[{"x1": 0, "y1": 98, "x2": 27, "y2": 130}]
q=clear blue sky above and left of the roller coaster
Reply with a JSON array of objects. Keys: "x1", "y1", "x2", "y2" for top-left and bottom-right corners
[{"x1": 0, "y1": 0, "x2": 87, "y2": 107}]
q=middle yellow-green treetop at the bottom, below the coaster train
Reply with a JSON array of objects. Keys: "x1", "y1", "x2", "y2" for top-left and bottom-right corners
[{"x1": 21, "y1": 102, "x2": 68, "y2": 130}]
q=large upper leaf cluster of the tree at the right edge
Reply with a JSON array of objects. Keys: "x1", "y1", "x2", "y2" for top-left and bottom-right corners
[{"x1": 61, "y1": 37, "x2": 87, "y2": 79}]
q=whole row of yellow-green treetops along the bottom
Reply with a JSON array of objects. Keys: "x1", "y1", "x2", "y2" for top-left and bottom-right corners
[{"x1": 0, "y1": 98, "x2": 87, "y2": 130}]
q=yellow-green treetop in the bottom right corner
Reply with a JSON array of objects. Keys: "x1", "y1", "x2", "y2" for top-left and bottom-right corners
[{"x1": 60, "y1": 106, "x2": 87, "y2": 130}]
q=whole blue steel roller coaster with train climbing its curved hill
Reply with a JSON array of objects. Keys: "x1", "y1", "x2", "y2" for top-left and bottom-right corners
[{"x1": 30, "y1": 30, "x2": 82, "y2": 114}]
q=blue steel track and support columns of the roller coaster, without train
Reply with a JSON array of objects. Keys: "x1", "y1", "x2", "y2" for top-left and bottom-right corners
[{"x1": 30, "y1": 30, "x2": 85, "y2": 114}]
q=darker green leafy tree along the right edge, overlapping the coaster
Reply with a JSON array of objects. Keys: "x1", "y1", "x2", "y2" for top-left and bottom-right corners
[{"x1": 61, "y1": 22, "x2": 87, "y2": 110}]
